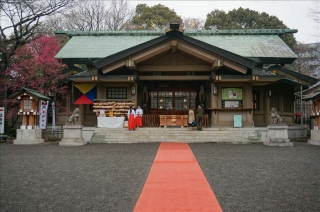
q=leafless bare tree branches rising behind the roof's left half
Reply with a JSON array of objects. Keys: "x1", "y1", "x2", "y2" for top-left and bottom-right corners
[{"x1": 46, "y1": 0, "x2": 134, "y2": 31}]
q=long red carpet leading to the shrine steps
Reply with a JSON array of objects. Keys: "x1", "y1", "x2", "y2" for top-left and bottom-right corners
[{"x1": 133, "y1": 143, "x2": 222, "y2": 212}]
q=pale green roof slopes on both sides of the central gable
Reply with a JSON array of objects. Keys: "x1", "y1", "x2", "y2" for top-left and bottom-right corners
[{"x1": 56, "y1": 29, "x2": 297, "y2": 64}]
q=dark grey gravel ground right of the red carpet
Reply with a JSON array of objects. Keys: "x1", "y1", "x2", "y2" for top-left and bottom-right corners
[{"x1": 190, "y1": 142, "x2": 320, "y2": 212}]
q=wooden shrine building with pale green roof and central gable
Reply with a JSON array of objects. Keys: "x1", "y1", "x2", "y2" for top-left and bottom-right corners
[{"x1": 56, "y1": 23, "x2": 317, "y2": 127}]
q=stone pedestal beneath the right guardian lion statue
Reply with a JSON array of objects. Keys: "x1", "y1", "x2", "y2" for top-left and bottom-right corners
[{"x1": 263, "y1": 125, "x2": 293, "y2": 146}]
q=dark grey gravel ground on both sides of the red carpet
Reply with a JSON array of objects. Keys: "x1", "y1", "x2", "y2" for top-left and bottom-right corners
[{"x1": 0, "y1": 142, "x2": 320, "y2": 212}]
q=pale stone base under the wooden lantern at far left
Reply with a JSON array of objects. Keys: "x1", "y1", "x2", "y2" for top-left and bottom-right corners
[{"x1": 13, "y1": 129, "x2": 44, "y2": 144}]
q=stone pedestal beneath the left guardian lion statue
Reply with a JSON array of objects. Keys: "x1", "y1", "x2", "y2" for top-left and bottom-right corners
[{"x1": 59, "y1": 124, "x2": 87, "y2": 146}]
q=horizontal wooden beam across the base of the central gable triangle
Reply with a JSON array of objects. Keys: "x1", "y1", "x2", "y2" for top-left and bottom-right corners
[{"x1": 137, "y1": 65, "x2": 211, "y2": 72}]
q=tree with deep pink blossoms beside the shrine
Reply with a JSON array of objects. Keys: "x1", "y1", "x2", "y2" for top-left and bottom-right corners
[{"x1": 0, "y1": 36, "x2": 68, "y2": 117}]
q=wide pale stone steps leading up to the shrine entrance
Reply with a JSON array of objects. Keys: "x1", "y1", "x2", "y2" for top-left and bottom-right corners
[{"x1": 89, "y1": 127, "x2": 268, "y2": 144}]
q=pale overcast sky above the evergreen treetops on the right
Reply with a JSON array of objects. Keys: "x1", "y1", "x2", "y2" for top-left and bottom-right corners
[{"x1": 131, "y1": 0, "x2": 320, "y2": 43}]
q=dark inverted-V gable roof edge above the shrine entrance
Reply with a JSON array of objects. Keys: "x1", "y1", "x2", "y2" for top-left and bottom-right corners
[{"x1": 95, "y1": 30, "x2": 254, "y2": 69}]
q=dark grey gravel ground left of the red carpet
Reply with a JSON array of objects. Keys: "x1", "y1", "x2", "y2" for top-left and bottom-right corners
[{"x1": 0, "y1": 143, "x2": 159, "y2": 212}]
